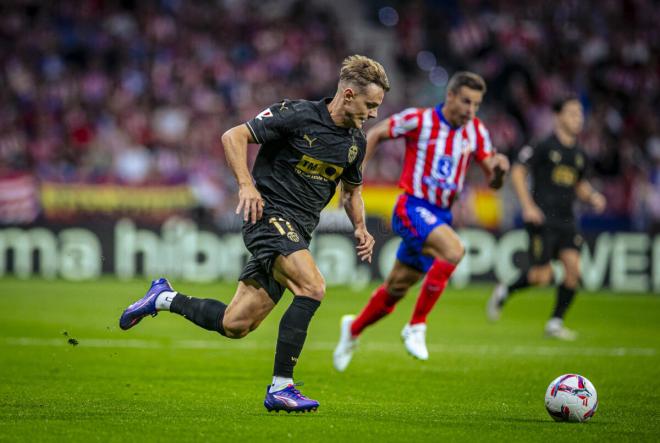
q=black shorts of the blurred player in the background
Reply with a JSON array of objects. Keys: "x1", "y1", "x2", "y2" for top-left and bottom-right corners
[{"x1": 525, "y1": 223, "x2": 583, "y2": 266}]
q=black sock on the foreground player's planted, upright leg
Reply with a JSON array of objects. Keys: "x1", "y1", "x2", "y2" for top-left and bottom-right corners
[{"x1": 273, "y1": 295, "x2": 321, "y2": 378}]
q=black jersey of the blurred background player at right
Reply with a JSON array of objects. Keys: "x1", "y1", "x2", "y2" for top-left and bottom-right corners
[{"x1": 518, "y1": 134, "x2": 586, "y2": 225}]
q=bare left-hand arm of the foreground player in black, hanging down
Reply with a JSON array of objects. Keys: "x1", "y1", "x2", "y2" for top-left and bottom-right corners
[{"x1": 222, "y1": 124, "x2": 264, "y2": 223}]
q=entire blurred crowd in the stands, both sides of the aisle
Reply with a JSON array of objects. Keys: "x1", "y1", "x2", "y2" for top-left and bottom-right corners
[{"x1": 0, "y1": 0, "x2": 660, "y2": 229}]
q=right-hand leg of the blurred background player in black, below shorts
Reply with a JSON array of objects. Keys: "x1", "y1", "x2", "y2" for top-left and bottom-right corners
[{"x1": 545, "y1": 248, "x2": 580, "y2": 340}]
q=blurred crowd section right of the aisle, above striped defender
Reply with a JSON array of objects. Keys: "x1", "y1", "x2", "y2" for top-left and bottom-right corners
[{"x1": 370, "y1": 0, "x2": 660, "y2": 232}]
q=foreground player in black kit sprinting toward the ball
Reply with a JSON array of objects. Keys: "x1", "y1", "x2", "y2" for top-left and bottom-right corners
[{"x1": 119, "y1": 55, "x2": 389, "y2": 412}]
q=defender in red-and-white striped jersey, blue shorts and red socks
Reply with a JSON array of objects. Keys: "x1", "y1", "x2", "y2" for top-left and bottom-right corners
[{"x1": 334, "y1": 72, "x2": 509, "y2": 371}]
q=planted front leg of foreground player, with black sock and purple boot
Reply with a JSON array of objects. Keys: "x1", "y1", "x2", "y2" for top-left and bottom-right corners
[{"x1": 264, "y1": 249, "x2": 325, "y2": 411}]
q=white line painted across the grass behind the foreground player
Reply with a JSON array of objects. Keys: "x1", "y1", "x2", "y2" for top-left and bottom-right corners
[{"x1": 0, "y1": 337, "x2": 658, "y2": 357}]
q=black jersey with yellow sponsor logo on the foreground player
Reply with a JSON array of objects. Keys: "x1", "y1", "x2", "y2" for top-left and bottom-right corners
[{"x1": 246, "y1": 98, "x2": 367, "y2": 236}]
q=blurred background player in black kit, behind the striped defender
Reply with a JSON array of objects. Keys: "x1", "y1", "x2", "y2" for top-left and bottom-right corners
[{"x1": 487, "y1": 97, "x2": 605, "y2": 340}]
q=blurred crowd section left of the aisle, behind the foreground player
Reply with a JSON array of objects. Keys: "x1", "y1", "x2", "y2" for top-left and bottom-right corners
[{"x1": 0, "y1": 0, "x2": 346, "y2": 215}]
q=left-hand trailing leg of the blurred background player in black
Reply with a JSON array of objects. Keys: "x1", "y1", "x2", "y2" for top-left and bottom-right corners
[{"x1": 486, "y1": 223, "x2": 552, "y2": 321}]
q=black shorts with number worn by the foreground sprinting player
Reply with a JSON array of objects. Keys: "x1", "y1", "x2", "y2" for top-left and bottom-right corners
[{"x1": 238, "y1": 214, "x2": 311, "y2": 303}]
